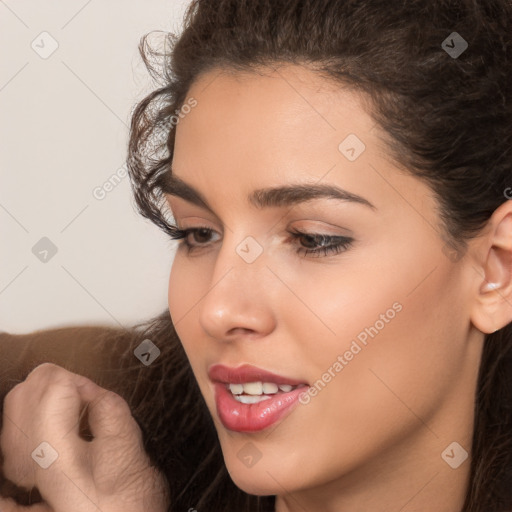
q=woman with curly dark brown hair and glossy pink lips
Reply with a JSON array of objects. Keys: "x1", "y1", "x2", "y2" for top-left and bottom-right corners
[{"x1": 2, "y1": 0, "x2": 512, "y2": 512}]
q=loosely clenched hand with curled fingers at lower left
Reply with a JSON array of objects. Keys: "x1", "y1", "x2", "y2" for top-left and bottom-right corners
[{"x1": 0, "y1": 363, "x2": 168, "y2": 512}]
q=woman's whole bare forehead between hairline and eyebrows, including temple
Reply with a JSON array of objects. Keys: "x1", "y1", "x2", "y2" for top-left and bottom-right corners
[{"x1": 172, "y1": 62, "x2": 435, "y2": 226}]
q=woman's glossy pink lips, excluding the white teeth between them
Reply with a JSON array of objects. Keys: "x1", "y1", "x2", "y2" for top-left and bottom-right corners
[{"x1": 208, "y1": 364, "x2": 307, "y2": 432}]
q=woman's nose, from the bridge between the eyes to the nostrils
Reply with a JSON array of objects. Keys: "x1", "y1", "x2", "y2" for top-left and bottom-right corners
[{"x1": 199, "y1": 238, "x2": 276, "y2": 341}]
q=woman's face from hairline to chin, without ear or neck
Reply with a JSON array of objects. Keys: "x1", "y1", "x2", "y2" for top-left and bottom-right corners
[{"x1": 166, "y1": 66, "x2": 480, "y2": 504}]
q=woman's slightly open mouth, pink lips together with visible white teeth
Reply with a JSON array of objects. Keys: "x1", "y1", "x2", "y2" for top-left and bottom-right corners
[{"x1": 208, "y1": 365, "x2": 309, "y2": 432}]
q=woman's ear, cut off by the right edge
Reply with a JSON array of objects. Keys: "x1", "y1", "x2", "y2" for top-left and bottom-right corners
[{"x1": 471, "y1": 200, "x2": 512, "y2": 333}]
